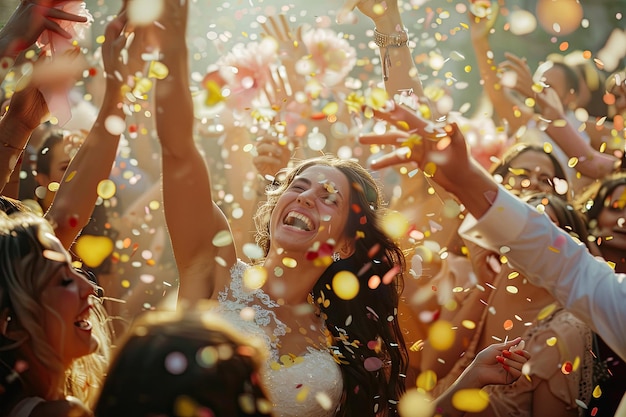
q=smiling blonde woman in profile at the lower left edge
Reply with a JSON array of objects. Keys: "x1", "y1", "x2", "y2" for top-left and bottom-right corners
[{"x1": 0, "y1": 213, "x2": 110, "y2": 416}]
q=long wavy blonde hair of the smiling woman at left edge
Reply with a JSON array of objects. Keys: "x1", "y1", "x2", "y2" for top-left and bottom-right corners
[{"x1": 0, "y1": 212, "x2": 111, "y2": 406}]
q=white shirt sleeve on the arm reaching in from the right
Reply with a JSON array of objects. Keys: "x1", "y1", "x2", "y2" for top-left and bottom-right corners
[{"x1": 459, "y1": 188, "x2": 626, "y2": 359}]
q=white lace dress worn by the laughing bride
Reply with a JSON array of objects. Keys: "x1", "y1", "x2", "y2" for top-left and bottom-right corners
[{"x1": 218, "y1": 261, "x2": 343, "y2": 417}]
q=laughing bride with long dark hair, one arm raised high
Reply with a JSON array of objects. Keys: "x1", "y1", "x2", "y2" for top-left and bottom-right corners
[{"x1": 156, "y1": 0, "x2": 525, "y2": 417}]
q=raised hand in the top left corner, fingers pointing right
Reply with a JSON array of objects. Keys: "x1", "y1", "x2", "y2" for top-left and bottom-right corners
[{"x1": 0, "y1": 0, "x2": 87, "y2": 58}]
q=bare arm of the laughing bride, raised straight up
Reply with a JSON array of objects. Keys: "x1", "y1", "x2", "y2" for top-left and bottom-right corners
[{"x1": 154, "y1": 0, "x2": 236, "y2": 302}]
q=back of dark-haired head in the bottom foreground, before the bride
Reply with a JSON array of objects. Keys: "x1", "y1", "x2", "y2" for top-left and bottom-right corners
[{"x1": 94, "y1": 309, "x2": 271, "y2": 417}]
